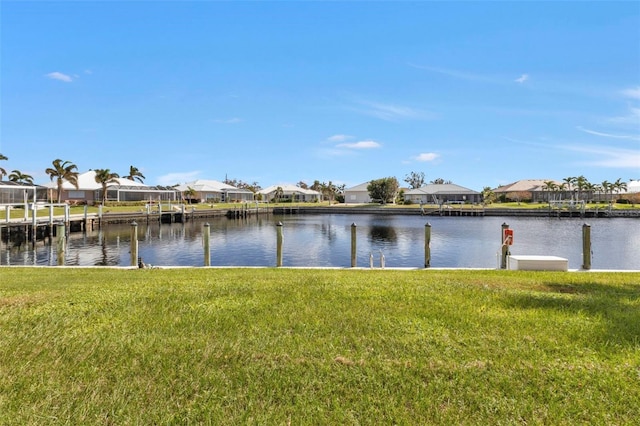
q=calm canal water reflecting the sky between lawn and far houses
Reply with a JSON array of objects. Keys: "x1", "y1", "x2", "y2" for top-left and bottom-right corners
[{"x1": 0, "y1": 214, "x2": 640, "y2": 270}]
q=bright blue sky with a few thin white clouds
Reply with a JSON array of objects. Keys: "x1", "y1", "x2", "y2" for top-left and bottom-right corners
[{"x1": 0, "y1": 0, "x2": 640, "y2": 191}]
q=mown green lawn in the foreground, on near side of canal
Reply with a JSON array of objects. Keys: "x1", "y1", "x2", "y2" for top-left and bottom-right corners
[{"x1": 0, "y1": 268, "x2": 640, "y2": 425}]
